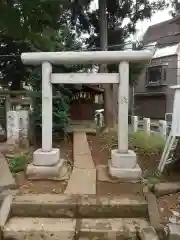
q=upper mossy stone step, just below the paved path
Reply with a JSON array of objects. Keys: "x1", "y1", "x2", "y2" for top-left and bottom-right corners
[{"x1": 10, "y1": 194, "x2": 148, "y2": 218}]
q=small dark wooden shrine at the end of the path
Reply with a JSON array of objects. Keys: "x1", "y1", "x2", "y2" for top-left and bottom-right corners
[{"x1": 70, "y1": 85, "x2": 104, "y2": 121}]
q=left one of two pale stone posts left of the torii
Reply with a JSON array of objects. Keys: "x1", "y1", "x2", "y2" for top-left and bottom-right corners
[{"x1": 7, "y1": 111, "x2": 19, "y2": 144}]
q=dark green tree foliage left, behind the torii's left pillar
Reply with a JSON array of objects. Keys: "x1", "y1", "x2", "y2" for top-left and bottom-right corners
[{"x1": 0, "y1": 0, "x2": 81, "y2": 133}]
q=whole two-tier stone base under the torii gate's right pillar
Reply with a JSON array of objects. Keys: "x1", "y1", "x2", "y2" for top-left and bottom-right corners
[{"x1": 108, "y1": 149, "x2": 142, "y2": 182}]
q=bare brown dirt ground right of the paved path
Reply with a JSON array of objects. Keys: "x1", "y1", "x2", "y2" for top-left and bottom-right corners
[{"x1": 88, "y1": 136, "x2": 180, "y2": 223}]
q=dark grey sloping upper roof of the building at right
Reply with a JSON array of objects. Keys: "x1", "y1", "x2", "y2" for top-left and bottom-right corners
[{"x1": 143, "y1": 19, "x2": 180, "y2": 47}]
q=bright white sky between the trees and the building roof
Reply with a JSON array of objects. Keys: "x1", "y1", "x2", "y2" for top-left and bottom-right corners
[{"x1": 92, "y1": 0, "x2": 171, "y2": 38}]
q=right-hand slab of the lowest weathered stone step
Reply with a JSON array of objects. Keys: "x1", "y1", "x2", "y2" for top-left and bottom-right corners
[{"x1": 79, "y1": 218, "x2": 148, "y2": 240}]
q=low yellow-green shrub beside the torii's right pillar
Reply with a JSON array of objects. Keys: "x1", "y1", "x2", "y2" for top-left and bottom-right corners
[{"x1": 129, "y1": 131, "x2": 165, "y2": 155}]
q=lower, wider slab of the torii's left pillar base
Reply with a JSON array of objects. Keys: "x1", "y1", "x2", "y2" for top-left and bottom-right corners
[{"x1": 26, "y1": 159, "x2": 70, "y2": 181}]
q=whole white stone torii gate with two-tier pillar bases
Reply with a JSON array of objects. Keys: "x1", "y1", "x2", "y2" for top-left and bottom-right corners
[{"x1": 21, "y1": 51, "x2": 152, "y2": 180}]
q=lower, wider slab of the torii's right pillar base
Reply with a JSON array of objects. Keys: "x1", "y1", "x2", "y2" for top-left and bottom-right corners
[{"x1": 108, "y1": 161, "x2": 142, "y2": 183}]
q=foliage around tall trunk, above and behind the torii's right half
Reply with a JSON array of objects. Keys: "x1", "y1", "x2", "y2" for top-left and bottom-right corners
[{"x1": 72, "y1": 0, "x2": 167, "y2": 78}]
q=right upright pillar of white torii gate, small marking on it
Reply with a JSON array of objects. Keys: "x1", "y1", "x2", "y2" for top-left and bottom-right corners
[{"x1": 118, "y1": 61, "x2": 129, "y2": 153}]
